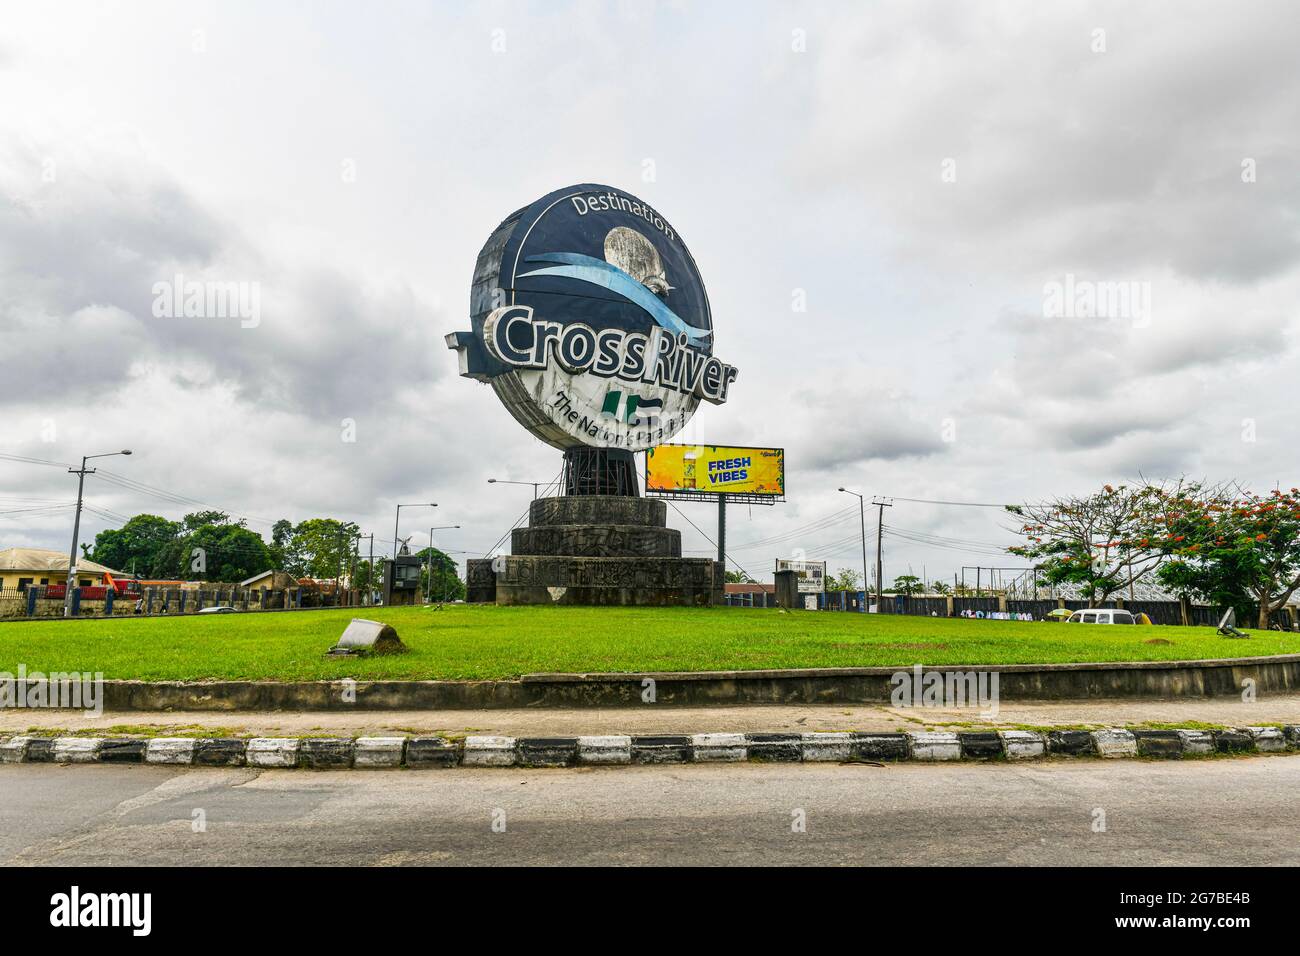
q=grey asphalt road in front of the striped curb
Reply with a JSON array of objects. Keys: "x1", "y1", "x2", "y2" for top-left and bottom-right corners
[{"x1": 0, "y1": 754, "x2": 1300, "y2": 866}]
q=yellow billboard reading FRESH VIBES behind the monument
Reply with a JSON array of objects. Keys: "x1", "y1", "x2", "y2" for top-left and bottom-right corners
[{"x1": 646, "y1": 445, "x2": 785, "y2": 497}]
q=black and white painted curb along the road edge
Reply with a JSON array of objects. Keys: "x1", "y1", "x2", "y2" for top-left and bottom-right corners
[{"x1": 0, "y1": 726, "x2": 1300, "y2": 770}]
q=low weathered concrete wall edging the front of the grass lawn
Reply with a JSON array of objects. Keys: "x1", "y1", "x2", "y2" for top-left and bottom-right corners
[{"x1": 50, "y1": 654, "x2": 1300, "y2": 711}]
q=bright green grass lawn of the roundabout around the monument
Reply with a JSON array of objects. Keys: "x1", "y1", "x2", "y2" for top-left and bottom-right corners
[{"x1": 0, "y1": 605, "x2": 1300, "y2": 680}]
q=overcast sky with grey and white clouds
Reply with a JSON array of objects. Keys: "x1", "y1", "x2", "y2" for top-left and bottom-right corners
[{"x1": 0, "y1": 1, "x2": 1300, "y2": 590}]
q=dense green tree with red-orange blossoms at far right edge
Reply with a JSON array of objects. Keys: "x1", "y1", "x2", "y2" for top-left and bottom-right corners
[{"x1": 1144, "y1": 485, "x2": 1300, "y2": 628}]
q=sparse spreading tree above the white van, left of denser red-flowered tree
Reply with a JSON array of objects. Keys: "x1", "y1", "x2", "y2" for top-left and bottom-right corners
[{"x1": 1006, "y1": 483, "x2": 1183, "y2": 607}]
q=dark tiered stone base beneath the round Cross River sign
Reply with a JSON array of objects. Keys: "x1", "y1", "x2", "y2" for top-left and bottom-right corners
[{"x1": 467, "y1": 496, "x2": 723, "y2": 607}]
